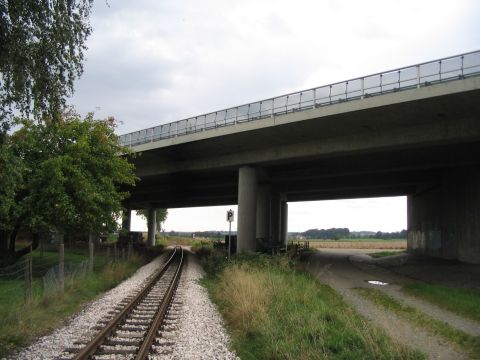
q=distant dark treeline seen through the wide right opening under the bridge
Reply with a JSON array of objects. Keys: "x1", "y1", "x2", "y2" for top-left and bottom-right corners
[{"x1": 297, "y1": 228, "x2": 407, "y2": 240}]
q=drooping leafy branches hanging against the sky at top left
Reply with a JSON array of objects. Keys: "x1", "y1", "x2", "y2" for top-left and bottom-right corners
[{"x1": 0, "y1": 0, "x2": 93, "y2": 129}]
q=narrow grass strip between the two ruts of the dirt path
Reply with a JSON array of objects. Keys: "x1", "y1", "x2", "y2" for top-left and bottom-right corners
[{"x1": 357, "y1": 288, "x2": 480, "y2": 359}]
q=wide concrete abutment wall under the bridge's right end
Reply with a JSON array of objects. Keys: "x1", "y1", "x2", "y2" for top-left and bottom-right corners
[{"x1": 408, "y1": 167, "x2": 480, "y2": 263}]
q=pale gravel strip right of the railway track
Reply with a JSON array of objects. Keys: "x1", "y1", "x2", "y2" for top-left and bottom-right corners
[{"x1": 151, "y1": 256, "x2": 240, "y2": 360}]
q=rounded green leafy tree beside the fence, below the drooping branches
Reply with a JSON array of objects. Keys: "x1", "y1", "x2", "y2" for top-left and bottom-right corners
[{"x1": 0, "y1": 113, "x2": 136, "y2": 262}]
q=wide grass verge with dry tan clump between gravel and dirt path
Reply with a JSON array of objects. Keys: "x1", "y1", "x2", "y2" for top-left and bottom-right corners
[{"x1": 202, "y1": 252, "x2": 424, "y2": 360}]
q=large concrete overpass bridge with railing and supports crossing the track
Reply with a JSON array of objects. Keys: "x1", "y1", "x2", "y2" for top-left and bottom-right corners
[{"x1": 120, "y1": 51, "x2": 480, "y2": 263}]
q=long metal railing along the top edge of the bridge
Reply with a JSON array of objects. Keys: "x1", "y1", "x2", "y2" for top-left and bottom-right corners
[{"x1": 119, "y1": 50, "x2": 480, "y2": 147}]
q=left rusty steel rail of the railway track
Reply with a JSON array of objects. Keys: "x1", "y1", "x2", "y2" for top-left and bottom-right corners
[{"x1": 72, "y1": 248, "x2": 183, "y2": 360}]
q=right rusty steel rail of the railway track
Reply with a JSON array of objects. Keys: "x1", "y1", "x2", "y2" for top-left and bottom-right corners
[{"x1": 135, "y1": 248, "x2": 183, "y2": 360}]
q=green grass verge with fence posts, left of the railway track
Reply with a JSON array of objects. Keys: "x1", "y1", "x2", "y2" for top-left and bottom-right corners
[{"x1": 0, "y1": 253, "x2": 145, "y2": 357}]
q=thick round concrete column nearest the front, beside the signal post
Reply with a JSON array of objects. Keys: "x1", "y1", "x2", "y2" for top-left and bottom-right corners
[{"x1": 237, "y1": 166, "x2": 257, "y2": 253}]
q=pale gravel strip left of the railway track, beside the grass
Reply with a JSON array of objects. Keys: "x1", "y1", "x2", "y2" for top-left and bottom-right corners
[{"x1": 2, "y1": 255, "x2": 165, "y2": 360}]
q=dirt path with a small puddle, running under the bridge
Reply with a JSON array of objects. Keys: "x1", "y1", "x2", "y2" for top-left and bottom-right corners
[{"x1": 305, "y1": 249, "x2": 480, "y2": 359}]
